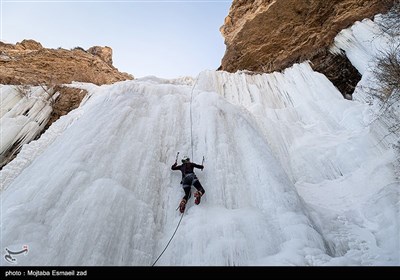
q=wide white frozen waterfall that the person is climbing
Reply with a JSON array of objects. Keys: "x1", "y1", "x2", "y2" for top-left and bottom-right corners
[{"x1": 0, "y1": 19, "x2": 400, "y2": 266}]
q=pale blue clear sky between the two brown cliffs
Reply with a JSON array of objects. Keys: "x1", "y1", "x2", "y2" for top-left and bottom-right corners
[{"x1": 0, "y1": 0, "x2": 232, "y2": 78}]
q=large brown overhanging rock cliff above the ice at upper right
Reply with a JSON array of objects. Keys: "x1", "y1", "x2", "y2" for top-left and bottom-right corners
[{"x1": 220, "y1": 0, "x2": 390, "y2": 95}]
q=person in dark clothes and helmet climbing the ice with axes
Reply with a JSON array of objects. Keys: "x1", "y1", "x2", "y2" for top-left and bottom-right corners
[{"x1": 171, "y1": 156, "x2": 206, "y2": 213}]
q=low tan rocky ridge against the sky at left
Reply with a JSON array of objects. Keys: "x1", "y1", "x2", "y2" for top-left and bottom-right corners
[{"x1": 0, "y1": 40, "x2": 133, "y2": 85}]
